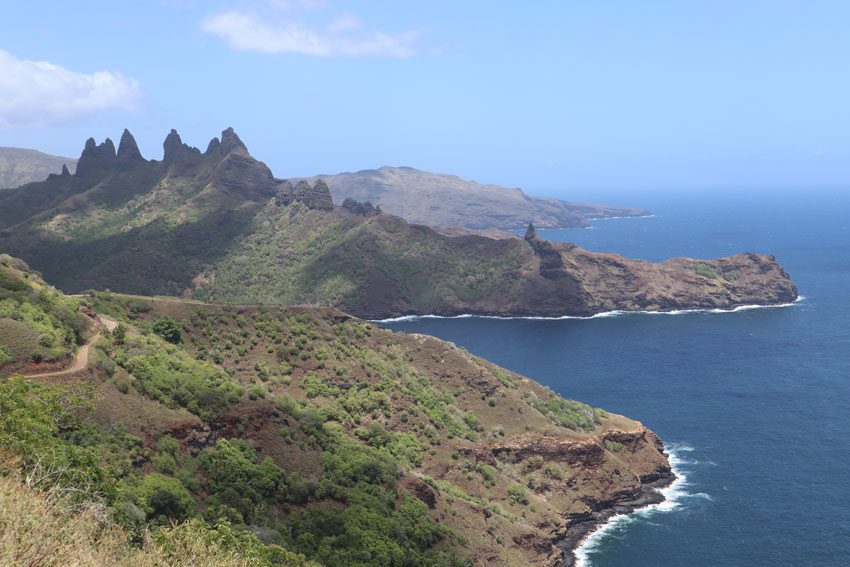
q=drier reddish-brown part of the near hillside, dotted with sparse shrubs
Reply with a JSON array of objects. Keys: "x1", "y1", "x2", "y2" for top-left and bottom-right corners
[{"x1": 83, "y1": 295, "x2": 664, "y2": 565}]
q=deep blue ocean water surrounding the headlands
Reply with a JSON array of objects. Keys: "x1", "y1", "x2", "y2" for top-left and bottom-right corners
[{"x1": 387, "y1": 190, "x2": 850, "y2": 567}]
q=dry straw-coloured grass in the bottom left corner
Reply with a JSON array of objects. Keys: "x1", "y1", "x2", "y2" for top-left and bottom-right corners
[{"x1": 0, "y1": 468, "x2": 258, "y2": 567}]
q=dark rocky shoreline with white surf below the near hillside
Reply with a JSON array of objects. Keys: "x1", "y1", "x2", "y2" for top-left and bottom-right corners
[{"x1": 555, "y1": 470, "x2": 677, "y2": 567}]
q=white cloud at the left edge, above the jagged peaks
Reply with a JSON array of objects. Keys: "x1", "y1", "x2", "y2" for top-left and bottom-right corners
[{"x1": 0, "y1": 50, "x2": 140, "y2": 127}]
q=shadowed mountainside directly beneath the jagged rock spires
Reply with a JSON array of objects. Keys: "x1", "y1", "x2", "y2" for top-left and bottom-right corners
[{"x1": 0, "y1": 158, "x2": 258, "y2": 294}]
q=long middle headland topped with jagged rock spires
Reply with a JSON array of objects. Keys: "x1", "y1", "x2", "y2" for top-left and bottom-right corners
[{"x1": 0, "y1": 129, "x2": 797, "y2": 319}]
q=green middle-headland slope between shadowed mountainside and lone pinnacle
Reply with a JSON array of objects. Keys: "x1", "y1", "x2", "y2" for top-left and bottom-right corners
[{"x1": 195, "y1": 203, "x2": 534, "y2": 313}]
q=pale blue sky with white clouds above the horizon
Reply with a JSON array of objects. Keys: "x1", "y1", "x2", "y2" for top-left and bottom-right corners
[{"x1": 0, "y1": 0, "x2": 850, "y2": 196}]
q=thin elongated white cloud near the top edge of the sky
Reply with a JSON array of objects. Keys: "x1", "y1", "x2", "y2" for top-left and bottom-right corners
[{"x1": 201, "y1": 8, "x2": 418, "y2": 58}]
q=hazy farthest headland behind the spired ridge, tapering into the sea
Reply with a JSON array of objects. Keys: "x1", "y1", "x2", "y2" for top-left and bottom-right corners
[{"x1": 293, "y1": 166, "x2": 651, "y2": 230}]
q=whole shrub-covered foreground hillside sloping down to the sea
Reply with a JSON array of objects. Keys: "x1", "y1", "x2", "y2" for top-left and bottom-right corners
[{"x1": 0, "y1": 260, "x2": 671, "y2": 566}]
